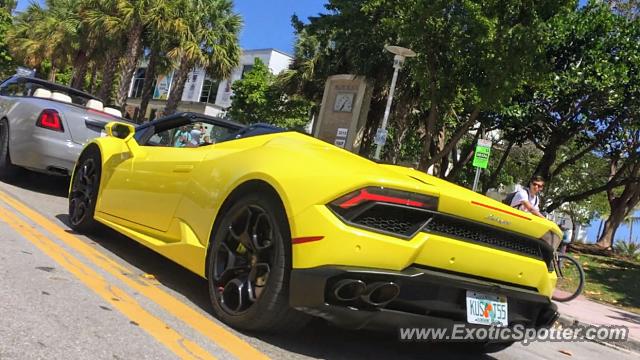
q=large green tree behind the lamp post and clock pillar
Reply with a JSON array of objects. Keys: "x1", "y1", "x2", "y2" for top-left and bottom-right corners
[{"x1": 290, "y1": 0, "x2": 573, "y2": 176}]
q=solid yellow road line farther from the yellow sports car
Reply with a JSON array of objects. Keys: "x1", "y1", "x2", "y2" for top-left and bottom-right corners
[{"x1": 0, "y1": 207, "x2": 215, "y2": 359}]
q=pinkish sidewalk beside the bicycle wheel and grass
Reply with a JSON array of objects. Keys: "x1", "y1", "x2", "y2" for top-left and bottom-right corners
[{"x1": 556, "y1": 296, "x2": 640, "y2": 352}]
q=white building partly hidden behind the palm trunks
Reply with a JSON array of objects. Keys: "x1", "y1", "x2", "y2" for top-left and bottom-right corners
[{"x1": 126, "y1": 49, "x2": 293, "y2": 119}]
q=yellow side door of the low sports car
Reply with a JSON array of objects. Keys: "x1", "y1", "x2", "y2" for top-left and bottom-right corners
[{"x1": 101, "y1": 121, "x2": 206, "y2": 232}]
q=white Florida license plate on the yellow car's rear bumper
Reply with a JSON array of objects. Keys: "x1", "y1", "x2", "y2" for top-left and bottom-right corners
[{"x1": 467, "y1": 290, "x2": 509, "y2": 326}]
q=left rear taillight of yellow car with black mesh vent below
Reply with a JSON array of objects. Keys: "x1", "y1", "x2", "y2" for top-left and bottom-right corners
[{"x1": 327, "y1": 187, "x2": 438, "y2": 239}]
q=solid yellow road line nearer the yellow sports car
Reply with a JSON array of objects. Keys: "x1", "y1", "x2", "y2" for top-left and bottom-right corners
[{"x1": 0, "y1": 191, "x2": 268, "y2": 359}]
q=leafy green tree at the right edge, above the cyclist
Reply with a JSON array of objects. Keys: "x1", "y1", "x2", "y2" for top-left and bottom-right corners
[{"x1": 502, "y1": 2, "x2": 638, "y2": 181}]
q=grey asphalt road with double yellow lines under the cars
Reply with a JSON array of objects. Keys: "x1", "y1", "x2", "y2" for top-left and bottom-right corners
[{"x1": 0, "y1": 173, "x2": 638, "y2": 360}]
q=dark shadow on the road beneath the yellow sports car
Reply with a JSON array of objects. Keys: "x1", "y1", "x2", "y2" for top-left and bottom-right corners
[{"x1": 56, "y1": 214, "x2": 493, "y2": 359}]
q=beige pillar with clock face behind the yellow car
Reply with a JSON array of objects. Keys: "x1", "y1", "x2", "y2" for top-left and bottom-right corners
[{"x1": 313, "y1": 75, "x2": 373, "y2": 153}]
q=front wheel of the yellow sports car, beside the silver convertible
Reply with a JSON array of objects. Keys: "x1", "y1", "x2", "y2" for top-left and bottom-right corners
[{"x1": 69, "y1": 148, "x2": 102, "y2": 233}]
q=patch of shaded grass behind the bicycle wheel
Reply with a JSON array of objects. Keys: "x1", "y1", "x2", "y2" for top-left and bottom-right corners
[{"x1": 558, "y1": 253, "x2": 640, "y2": 314}]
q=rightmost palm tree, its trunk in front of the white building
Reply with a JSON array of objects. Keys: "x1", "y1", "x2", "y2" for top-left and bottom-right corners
[{"x1": 164, "y1": 0, "x2": 242, "y2": 115}]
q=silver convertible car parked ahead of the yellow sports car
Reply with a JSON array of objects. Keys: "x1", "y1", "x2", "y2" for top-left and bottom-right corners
[{"x1": 0, "y1": 76, "x2": 122, "y2": 179}]
